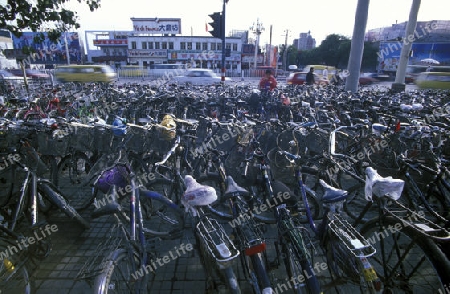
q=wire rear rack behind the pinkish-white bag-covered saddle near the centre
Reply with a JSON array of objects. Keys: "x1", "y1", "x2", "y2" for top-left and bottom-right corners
[{"x1": 196, "y1": 218, "x2": 239, "y2": 269}]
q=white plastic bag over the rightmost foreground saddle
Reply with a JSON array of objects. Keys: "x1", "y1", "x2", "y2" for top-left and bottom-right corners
[{"x1": 364, "y1": 167, "x2": 405, "y2": 201}]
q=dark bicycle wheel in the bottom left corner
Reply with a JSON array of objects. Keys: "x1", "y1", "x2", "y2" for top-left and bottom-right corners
[{"x1": 0, "y1": 239, "x2": 33, "y2": 294}]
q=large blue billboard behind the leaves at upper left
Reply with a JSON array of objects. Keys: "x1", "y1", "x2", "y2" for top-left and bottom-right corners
[{"x1": 12, "y1": 32, "x2": 82, "y2": 64}]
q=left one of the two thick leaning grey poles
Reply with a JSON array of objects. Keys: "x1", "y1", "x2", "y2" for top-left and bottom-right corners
[{"x1": 345, "y1": 0, "x2": 369, "y2": 92}]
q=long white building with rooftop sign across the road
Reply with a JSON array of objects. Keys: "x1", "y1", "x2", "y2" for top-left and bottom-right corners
[{"x1": 86, "y1": 18, "x2": 244, "y2": 73}]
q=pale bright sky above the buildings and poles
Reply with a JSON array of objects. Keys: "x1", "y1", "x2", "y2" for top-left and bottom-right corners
[{"x1": 0, "y1": 0, "x2": 450, "y2": 46}]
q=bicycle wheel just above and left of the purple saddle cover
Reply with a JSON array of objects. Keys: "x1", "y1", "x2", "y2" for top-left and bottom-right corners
[{"x1": 56, "y1": 152, "x2": 93, "y2": 187}]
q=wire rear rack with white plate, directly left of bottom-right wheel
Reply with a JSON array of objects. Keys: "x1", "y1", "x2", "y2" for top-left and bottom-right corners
[{"x1": 328, "y1": 215, "x2": 376, "y2": 258}]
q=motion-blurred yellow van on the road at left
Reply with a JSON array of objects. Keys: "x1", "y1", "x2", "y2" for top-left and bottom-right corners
[{"x1": 55, "y1": 65, "x2": 116, "y2": 83}]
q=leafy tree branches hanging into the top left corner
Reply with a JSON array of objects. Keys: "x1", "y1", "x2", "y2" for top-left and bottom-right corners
[{"x1": 0, "y1": 0, "x2": 100, "y2": 41}]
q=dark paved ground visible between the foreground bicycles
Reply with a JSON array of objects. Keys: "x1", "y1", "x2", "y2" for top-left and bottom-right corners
[{"x1": 9, "y1": 170, "x2": 334, "y2": 294}]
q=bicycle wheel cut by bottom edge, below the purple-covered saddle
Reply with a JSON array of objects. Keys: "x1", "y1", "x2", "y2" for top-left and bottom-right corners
[{"x1": 94, "y1": 249, "x2": 148, "y2": 294}]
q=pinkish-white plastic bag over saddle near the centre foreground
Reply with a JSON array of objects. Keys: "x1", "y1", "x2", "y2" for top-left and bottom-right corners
[{"x1": 181, "y1": 175, "x2": 217, "y2": 216}]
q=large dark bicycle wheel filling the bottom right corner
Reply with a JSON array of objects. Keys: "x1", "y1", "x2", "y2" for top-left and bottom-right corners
[{"x1": 360, "y1": 216, "x2": 450, "y2": 293}]
